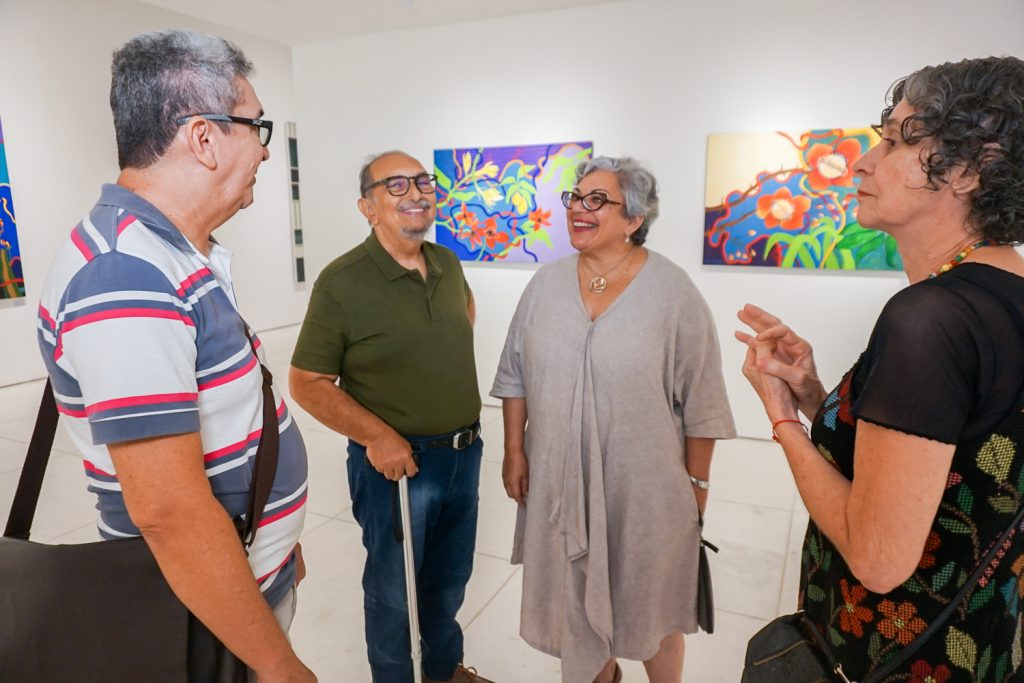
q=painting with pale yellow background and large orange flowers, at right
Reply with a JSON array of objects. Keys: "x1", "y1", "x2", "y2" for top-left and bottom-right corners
[{"x1": 703, "y1": 128, "x2": 903, "y2": 270}]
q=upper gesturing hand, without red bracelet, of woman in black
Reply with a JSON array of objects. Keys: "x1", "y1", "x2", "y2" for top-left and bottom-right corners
[{"x1": 735, "y1": 304, "x2": 826, "y2": 418}]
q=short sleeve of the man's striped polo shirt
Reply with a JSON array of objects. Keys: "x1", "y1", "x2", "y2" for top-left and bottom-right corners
[{"x1": 56, "y1": 252, "x2": 199, "y2": 445}]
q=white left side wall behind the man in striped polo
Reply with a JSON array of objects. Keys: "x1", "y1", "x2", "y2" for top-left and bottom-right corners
[{"x1": 0, "y1": 0, "x2": 306, "y2": 386}]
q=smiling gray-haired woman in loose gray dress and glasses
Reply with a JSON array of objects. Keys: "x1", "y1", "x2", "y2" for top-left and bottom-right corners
[{"x1": 490, "y1": 157, "x2": 734, "y2": 683}]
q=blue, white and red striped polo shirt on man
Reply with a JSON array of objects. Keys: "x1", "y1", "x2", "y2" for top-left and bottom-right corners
[{"x1": 38, "y1": 184, "x2": 307, "y2": 605}]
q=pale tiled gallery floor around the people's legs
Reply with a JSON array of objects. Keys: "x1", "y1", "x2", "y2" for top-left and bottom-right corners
[{"x1": 0, "y1": 327, "x2": 807, "y2": 683}]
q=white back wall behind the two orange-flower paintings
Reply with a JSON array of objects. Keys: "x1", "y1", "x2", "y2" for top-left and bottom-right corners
[{"x1": 294, "y1": 0, "x2": 1024, "y2": 437}]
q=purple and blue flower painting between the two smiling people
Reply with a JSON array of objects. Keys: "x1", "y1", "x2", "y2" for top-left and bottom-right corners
[{"x1": 434, "y1": 142, "x2": 594, "y2": 263}]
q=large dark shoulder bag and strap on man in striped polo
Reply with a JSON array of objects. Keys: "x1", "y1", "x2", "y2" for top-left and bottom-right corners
[{"x1": 0, "y1": 348, "x2": 279, "y2": 683}]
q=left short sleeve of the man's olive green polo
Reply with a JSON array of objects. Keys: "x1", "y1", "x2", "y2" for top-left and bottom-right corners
[{"x1": 292, "y1": 274, "x2": 348, "y2": 376}]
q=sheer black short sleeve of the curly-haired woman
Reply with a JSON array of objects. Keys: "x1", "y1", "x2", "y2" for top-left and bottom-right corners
[{"x1": 852, "y1": 283, "x2": 984, "y2": 443}]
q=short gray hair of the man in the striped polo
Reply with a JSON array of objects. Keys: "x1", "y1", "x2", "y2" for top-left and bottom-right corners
[{"x1": 111, "y1": 30, "x2": 253, "y2": 169}]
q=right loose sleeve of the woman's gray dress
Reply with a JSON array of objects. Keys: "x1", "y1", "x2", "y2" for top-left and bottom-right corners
[{"x1": 674, "y1": 279, "x2": 736, "y2": 438}]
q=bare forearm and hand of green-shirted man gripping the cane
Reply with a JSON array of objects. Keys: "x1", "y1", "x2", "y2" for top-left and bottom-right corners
[{"x1": 288, "y1": 366, "x2": 419, "y2": 481}]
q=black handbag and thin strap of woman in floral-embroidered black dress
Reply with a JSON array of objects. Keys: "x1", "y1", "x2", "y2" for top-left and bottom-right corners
[{"x1": 740, "y1": 499, "x2": 1024, "y2": 683}]
